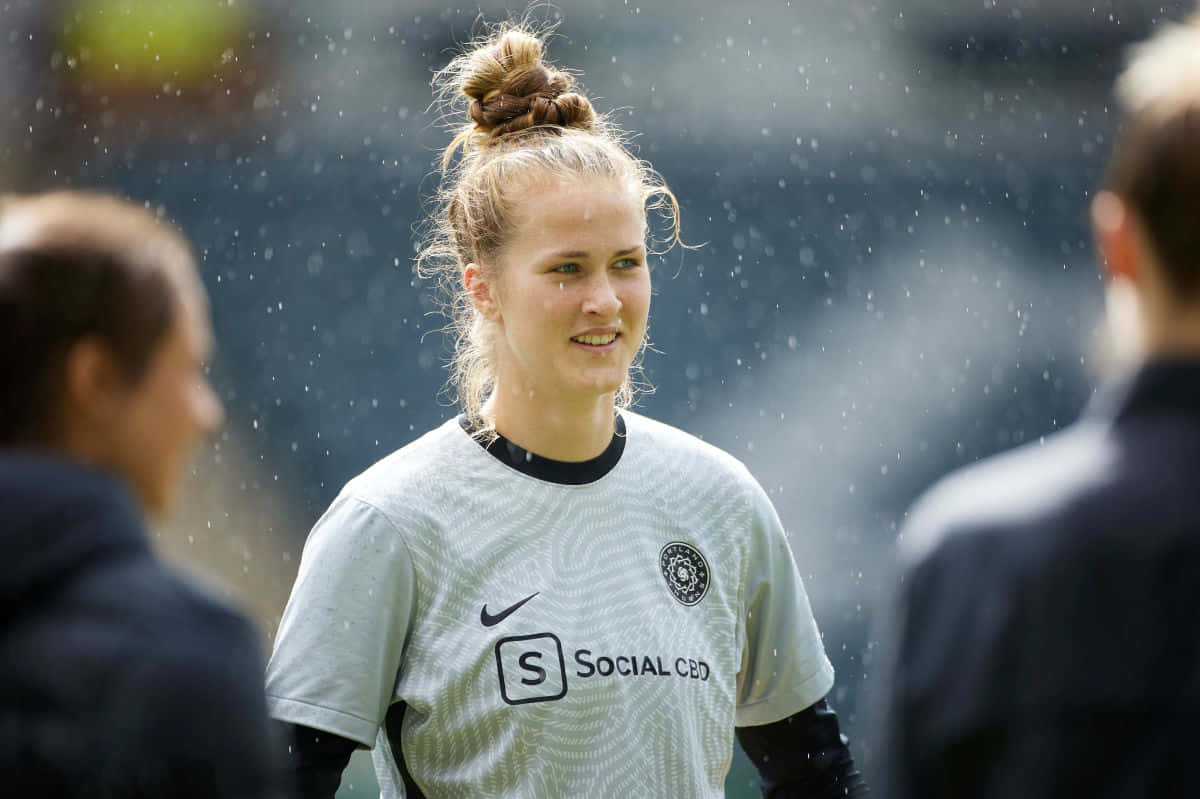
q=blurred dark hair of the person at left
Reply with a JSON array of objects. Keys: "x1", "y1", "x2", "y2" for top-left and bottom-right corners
[{"x1": 0, "y1": 192, "x2": 198, "y2": 445}]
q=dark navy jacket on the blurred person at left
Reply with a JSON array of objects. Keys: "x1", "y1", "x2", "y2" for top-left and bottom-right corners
[{"x1": 0, "y1": 450, "x2": 275, "y2": 799}]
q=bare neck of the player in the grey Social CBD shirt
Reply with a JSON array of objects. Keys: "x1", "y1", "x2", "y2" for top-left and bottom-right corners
[{"x1": 484, "y1": 385, "x2": 614, "y2": 462}]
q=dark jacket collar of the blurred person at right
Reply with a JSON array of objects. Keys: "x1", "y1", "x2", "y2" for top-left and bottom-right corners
[{"x1": 1088, "y1": 358, "x2": 1200, "y2": 423}]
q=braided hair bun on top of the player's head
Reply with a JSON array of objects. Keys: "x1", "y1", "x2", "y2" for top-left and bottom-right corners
[{"x1": 460, "y1": 30, "x2": 595, "y2": 138}]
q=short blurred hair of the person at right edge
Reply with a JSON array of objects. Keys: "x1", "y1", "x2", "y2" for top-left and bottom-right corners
[{"x1": 1104, "y1": 12, "x2": 1200, "y2": 300}]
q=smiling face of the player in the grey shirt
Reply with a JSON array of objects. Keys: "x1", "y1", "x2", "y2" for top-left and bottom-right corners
[{"x1": 488, "y1": 179, "x2": 650, "y2": 402}]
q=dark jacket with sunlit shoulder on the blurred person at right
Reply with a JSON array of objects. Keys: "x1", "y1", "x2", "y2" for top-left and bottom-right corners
[{"x1": 882, "y1": 361, "x2": 1200, "y2": 799}]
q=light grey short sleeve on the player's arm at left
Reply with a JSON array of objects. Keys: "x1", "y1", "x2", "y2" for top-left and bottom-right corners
[{"x1": 266, "y1": 494, "x2": 415, "y2": 747}]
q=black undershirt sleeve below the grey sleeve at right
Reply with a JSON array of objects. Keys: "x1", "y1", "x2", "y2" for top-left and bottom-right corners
[{"x1": 737, "y1": 699, "x2": 868, "y2": 799}]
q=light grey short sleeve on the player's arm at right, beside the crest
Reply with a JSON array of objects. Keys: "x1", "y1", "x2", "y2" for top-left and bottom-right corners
[{"x1": 736, "y1": 482, "x2": 833, "y2": 727}]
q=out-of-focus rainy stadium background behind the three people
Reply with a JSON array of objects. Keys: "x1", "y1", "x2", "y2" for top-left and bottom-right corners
[{"x1": 0, "y1": 0, "x2": 1190, "y2": 797}]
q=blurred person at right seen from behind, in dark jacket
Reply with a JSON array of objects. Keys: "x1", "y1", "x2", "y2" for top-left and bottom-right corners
[{"x1": 883, "y1": 18, "x2": 1200, "y2": 799}]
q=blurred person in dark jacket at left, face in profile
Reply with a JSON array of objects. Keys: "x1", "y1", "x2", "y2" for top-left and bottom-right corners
[{"x1": 0, "y1": 193, "x2": 276, "y2": 799}]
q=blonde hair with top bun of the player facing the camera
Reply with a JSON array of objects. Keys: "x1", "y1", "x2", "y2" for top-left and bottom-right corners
[{"x1": 418, "y1": 23, "x2": 679, "y2": 431}]
